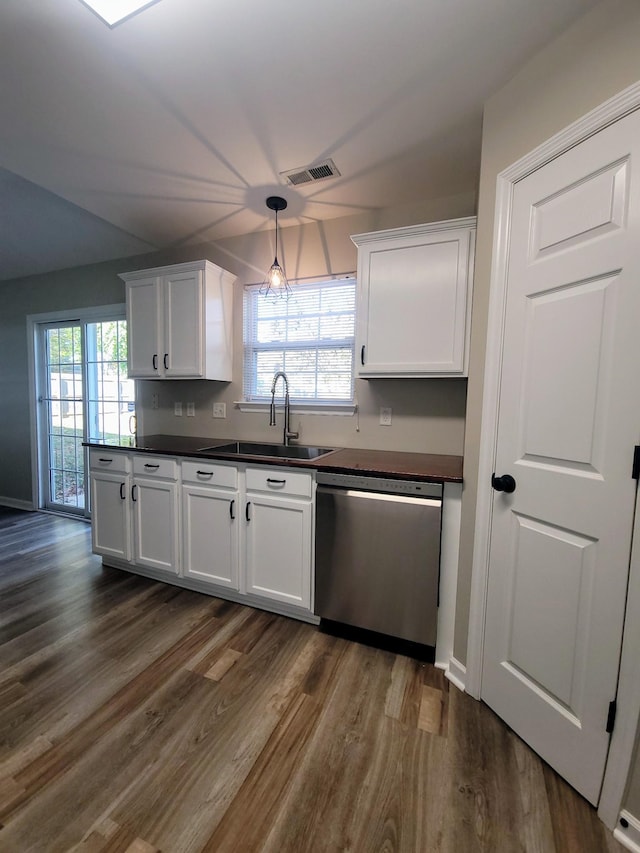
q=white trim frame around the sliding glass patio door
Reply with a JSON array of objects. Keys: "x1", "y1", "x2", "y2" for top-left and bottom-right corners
[{"x1": 27, "y1": 302, "x2": 125, "y2": 519}]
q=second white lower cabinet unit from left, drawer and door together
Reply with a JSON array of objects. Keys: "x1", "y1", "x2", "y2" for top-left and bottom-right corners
[{"x1": 131, "y1": 455, "x2": 178, "y2": 574}]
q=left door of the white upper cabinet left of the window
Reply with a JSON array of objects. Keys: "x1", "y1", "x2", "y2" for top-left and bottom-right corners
[{"x1": 127, "y1": 277, "x2": 165, "y2": 378}]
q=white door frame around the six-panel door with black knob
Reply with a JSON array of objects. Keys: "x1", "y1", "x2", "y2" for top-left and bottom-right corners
[{"x1": 465, "y1": 81, "x2": 640, "y2": 828}]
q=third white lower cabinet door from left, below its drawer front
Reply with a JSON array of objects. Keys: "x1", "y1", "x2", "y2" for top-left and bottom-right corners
[{"x1": 182, "y1": 485, "x2": 239, "y2": 590}]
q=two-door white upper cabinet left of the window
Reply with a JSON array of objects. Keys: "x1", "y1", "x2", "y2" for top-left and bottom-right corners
[{"x1": 120, "y1": 261, "x2": 235, "y2": 382}]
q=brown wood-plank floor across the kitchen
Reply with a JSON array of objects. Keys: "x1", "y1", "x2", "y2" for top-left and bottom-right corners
[{"x1": 0, "y1": 509, "x2": 623, "y2": 853}]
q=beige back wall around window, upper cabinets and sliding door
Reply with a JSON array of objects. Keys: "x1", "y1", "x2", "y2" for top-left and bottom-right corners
[{"x1": 0, "y1": 193, "x2": 476, "y2": 504}]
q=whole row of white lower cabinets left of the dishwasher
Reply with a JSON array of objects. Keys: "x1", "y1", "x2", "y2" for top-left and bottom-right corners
[{"x1": 90, "y1": 449, "x2": 317, "y2": 621}]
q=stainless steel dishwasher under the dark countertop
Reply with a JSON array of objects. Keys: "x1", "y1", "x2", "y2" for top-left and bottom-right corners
[{"x1": 315, "y1": 471, "x2": 442, "y2": 646}]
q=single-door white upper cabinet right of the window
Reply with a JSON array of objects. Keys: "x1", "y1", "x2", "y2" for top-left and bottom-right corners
[{"x1": 351, "y1": 217, "x2": 476, "y2": 379}]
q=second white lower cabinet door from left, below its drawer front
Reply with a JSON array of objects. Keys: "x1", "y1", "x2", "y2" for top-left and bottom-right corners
[{"x1": 131, "y1": 477, "x2": 178, "y2": 574}]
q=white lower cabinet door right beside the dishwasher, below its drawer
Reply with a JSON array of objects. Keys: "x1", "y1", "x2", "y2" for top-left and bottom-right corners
[{"x1": 245, "y1": 493, "x2": 312, "y2": 610}]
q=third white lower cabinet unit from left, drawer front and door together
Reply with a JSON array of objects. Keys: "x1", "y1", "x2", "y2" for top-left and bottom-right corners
[{"x1": 182, "y1": 462, "x2": 240, "y2": 590}]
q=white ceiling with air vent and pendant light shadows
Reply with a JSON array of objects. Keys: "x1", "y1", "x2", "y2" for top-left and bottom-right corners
[{"x1": 0, "y1": 0, "x2": 596, "y2": 279}]
